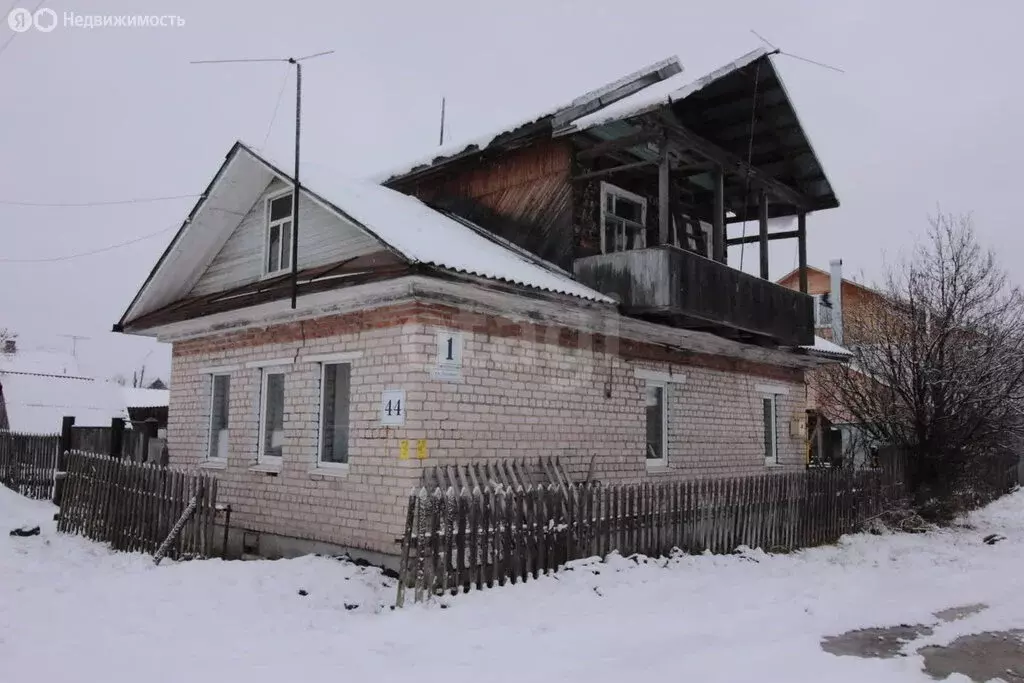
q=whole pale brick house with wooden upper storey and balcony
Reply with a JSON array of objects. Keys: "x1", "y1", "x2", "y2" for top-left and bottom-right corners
[{"x1": 115, "y1": 46, "x2": 842, "y2": 561}]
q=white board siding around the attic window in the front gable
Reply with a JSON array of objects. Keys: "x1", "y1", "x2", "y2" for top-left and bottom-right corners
[{"x1": 189, "y1": 179, "x2": 383, "y2": 296}]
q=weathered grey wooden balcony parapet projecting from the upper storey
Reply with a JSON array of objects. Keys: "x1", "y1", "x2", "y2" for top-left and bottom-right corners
[{"x1": 574, "y1": 246, "x2": 814, "y2": 346}]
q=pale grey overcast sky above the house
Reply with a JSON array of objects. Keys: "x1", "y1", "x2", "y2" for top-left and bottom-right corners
[{"x1": 0, "y1": 0, "x2": 1024, "y2": 376}]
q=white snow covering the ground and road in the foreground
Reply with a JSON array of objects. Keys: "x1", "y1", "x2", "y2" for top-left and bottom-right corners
[{"x1": 0, "y1": 488, "x2": 1024, "y2": 683}]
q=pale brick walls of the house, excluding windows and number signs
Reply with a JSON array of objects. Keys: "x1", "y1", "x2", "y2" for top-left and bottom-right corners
[{"x1": 168, "y1": 304, "x2": 806, "y2": 553}]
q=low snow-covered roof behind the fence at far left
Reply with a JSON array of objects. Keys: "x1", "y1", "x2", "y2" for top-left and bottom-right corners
[{"x1": 0, "y1": 372, "x2": 128, "y2": 434}]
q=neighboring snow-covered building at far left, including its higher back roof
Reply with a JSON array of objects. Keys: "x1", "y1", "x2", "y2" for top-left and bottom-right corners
[{"x1": 0, "y1": 343, "x2": 128, "y2": 434}]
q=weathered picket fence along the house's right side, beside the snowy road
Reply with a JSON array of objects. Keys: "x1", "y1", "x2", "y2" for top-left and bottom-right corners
[{"x1": 397, "y1": 469, "x2": 905, "y2": 606}]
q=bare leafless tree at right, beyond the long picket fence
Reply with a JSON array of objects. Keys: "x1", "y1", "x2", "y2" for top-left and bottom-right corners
[{"x1": 819, "y1": 215, "x2": 1024, "y2": 516}]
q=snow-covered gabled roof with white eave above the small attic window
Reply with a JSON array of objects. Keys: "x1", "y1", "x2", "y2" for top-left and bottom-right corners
[{"x1": 116, "y1": 142, "x2": 612, "y2": 329}]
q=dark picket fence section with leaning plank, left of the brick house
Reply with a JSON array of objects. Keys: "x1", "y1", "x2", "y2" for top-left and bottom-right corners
[{"x1": 57, "y1": 451, "x2": 217, "y2": 558}]
